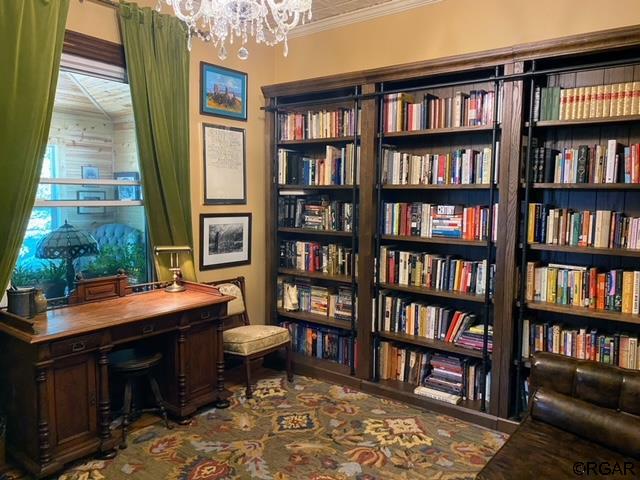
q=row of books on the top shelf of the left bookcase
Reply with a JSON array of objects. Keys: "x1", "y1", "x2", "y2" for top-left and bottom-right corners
[{"x1": 278, "y1": 108, "x2": 360, "y2": 140}]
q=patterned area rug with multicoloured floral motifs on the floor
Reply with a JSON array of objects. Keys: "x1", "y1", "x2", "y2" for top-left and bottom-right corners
[{"x1": 3, "y1": 375, "x2": 506, "y2": 480}]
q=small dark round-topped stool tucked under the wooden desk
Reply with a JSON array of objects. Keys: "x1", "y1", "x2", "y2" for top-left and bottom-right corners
[{"x1": 111, "y1": 351, "x2": 172, "y2": 449}]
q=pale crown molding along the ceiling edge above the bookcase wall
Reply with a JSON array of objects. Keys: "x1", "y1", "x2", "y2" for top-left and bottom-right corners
[{"x1": 288, "y1": 0, "x2": 442, "y2": 38}]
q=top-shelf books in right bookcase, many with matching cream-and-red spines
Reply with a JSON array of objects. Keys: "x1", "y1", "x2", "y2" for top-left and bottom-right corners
[{"x1": 533, "y1": 82, "x2": 640, "y2": 120}]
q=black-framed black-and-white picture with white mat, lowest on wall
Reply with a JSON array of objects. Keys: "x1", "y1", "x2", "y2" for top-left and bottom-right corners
[{"x1": 200, "y1": 213, "x2": 251, "y2": 270}]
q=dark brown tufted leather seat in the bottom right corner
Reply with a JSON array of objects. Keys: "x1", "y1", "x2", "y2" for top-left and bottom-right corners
[{"x1": 476, "y1": 352, "x2": 640, "y2": 480}]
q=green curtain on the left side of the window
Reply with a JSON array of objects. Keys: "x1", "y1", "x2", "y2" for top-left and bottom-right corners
[{"x1": 0, "y1": 0, "x2": 69, "y2": 290}]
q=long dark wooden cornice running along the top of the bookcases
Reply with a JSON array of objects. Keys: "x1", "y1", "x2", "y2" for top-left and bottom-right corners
[{"x1": 262, "y1": 25, "x2": 640, "y2": 97}]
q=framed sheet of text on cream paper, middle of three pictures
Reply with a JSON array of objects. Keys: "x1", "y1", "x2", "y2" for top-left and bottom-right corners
[{"x1": 202, "y1": 123, "x2": 247, "y2": 205}]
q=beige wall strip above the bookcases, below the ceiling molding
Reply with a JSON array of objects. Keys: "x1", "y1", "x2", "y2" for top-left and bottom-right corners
[{"x1": 275, "y1": 0, "x2": 640, "y2": 82}]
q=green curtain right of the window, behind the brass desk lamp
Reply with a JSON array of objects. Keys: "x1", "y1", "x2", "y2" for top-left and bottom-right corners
[{"x1": 119, "y1": 3, "x2": 195, "y2": 280}]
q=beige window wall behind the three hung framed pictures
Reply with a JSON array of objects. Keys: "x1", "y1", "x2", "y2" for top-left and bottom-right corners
[{"x1": 67, "y1": 0, "x2": 275, "y2": 323}]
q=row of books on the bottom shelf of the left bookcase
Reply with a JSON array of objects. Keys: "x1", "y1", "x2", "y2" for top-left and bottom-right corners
[{"x1": 280, "y1": 322, "x2": 357, "y2": 365}]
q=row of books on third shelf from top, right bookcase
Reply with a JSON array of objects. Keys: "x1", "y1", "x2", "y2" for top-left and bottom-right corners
[{"x1": 527, "y1": 203, "x2": 640, "y2": 249}]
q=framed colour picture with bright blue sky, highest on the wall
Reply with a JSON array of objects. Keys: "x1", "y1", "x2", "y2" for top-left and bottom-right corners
[{"x1": 200, "y1": 62, "x2": 247, "y2": 120}]
